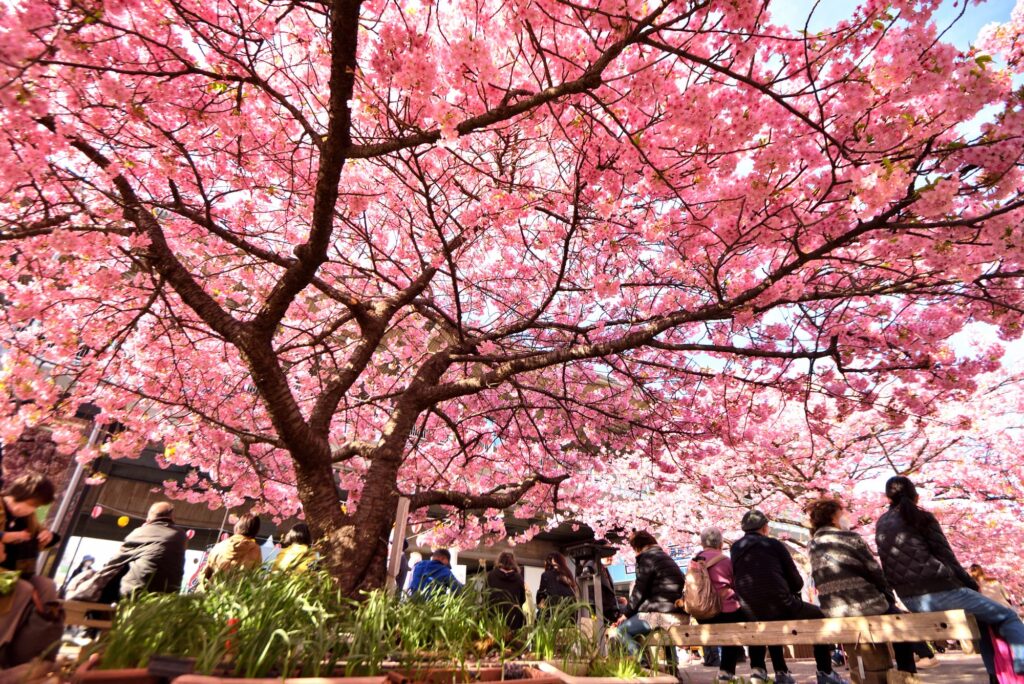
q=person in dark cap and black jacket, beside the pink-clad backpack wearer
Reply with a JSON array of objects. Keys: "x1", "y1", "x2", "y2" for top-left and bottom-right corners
[{"x1": 732, "y1": 509, "x2": 848, "y2": 684}]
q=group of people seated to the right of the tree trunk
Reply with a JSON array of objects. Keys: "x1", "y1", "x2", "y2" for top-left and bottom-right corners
[{"x1": 410, "y1": 476, "x2": 1024, "y2": 684}]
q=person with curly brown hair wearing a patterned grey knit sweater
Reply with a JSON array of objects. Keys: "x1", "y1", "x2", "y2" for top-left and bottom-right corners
[{"x1": 808, "y1": 499, "x2": 918, "y2": 681}]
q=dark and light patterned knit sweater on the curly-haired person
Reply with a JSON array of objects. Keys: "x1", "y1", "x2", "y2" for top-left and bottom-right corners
[{"x1": 809, "y1": 527, "x2": 895, "y2": 617}]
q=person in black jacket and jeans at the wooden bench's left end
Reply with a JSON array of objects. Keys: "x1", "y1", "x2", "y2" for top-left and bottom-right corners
[{"x1": 615, "y1": 529, "x2": 685, "y2": 653}]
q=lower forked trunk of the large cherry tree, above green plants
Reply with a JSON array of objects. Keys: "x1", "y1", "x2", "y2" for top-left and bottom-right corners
[{"x1": 295, "y1": 448, "x2": 400, "y2": 598}]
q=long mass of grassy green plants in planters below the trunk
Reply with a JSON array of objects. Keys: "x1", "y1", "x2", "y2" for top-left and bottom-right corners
[{"x1": 97, "y1": 572, "x2": 643, "y2": 679}]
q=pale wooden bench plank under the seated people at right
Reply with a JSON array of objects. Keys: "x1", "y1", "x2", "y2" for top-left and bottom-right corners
[{"x1": 651, "y1": 610, "x2": 981, "y2": 646}]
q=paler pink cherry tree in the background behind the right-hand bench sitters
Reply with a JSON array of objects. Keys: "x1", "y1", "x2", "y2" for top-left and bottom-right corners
[{"x1": 589, "y1": 369, "x2": 1024, "y2": 594}]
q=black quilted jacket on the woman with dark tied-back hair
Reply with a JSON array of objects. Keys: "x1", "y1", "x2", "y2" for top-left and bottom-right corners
[{"x1": 874, "y1": 508, "x2": 978, "y2": 597}]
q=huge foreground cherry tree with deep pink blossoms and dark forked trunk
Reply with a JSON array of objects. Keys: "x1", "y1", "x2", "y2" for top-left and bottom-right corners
[{"x1": 0, "y1": 0, "x2": 1024, "y2": 593}]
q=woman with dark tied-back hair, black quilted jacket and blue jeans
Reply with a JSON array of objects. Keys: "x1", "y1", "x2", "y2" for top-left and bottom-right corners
[{"x1": 874, "y1": 475, "x2": 1024, "y2": 676}]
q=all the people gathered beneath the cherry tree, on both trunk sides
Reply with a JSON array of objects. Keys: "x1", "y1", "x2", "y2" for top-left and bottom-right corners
[{"x1": 0, "y1": 466, "x2": 1024, "y2": 684}]
